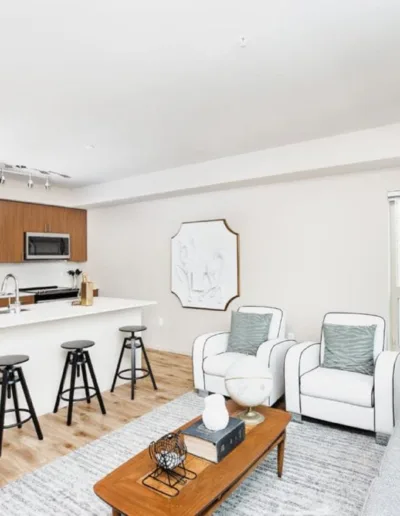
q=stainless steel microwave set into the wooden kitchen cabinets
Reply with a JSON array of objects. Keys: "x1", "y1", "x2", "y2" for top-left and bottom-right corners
[{"x1": 25, "y1": 233, "x2": 71, "y2": 260}]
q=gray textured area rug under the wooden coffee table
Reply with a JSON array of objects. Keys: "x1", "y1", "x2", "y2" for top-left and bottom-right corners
[{"x1": 0, "y1": 393, "x2": 384, "y2": 516}]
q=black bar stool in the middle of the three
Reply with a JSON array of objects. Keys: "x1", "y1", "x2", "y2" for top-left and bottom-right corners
[{"x1": 53, "y1": 340, "x2": 106, "y2": 426}]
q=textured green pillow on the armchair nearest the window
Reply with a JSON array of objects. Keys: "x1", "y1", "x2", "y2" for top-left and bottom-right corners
[{"x1": 322, "y1": 324, "x2": 376, "y2": 375}]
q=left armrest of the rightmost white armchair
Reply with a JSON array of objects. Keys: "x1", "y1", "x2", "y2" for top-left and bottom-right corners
[{"x1": 285, "y1": 342, "x2": 321, "y2": 414}]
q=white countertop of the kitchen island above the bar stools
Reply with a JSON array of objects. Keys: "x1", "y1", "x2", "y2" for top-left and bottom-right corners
[{"x1": 0, "y1": 297, "x2": 157, "y2": 330}]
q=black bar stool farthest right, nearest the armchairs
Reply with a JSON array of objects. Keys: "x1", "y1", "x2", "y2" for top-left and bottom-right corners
[{"x1": 111, "y1": 326, "x2": 157, "y2": 400}]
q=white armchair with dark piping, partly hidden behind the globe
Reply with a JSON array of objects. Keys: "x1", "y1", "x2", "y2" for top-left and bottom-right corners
[{"x1": 193, "y1": 306, "x2": 295, "y2": 406}]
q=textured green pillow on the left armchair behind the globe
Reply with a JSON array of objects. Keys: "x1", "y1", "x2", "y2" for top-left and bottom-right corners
[{"x1": 227, "y1": 312, "x2": 272, "y2": 355}]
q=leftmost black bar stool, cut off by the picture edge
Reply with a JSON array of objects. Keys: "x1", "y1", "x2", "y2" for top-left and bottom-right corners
[{"x1": 0, "y1": 355, "x2": 43, "y2": 456}]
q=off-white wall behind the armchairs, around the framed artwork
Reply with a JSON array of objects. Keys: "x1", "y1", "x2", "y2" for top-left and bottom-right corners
[{"x1": 88, "y1": 170, "x2": 400, "y2": 354}]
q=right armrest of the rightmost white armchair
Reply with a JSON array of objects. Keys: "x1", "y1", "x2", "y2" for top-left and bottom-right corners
[{"x1": 374, "y1": 351, "x2": 400, "y2": 435}]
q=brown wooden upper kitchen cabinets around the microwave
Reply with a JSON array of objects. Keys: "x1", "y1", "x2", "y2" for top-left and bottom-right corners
[{"x1": 0, "y1": 200, "x2": 87, "y2": 263}]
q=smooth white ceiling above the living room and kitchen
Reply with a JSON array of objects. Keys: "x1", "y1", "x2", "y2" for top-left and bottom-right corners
[{"x1": 0, "y1": 0, "x2": 400, "y2": 186}]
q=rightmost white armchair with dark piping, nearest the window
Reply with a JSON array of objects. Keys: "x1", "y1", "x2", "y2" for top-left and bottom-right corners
[{"x1": 285, "y1": 313, "x2": 400, "y2": 444}]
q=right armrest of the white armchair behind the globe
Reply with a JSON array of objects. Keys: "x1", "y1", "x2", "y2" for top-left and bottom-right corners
[{"x1": 257, "y1": 338, "x2": 296, "y2": 406}]
